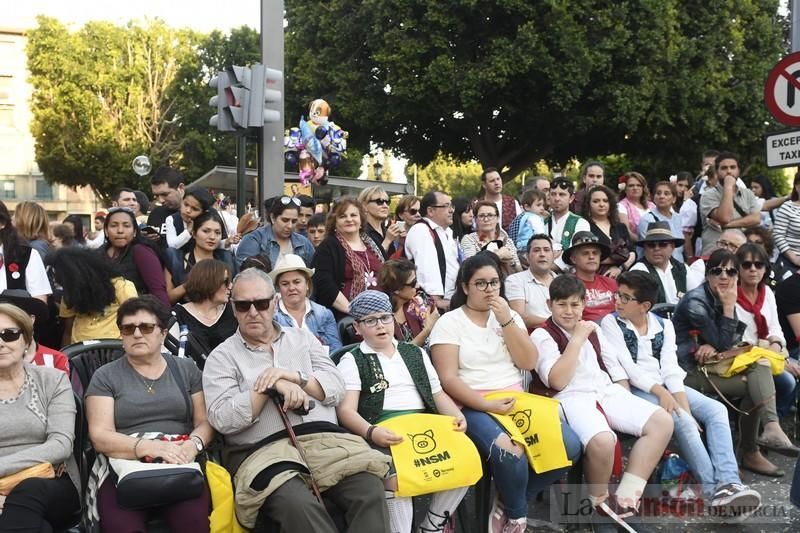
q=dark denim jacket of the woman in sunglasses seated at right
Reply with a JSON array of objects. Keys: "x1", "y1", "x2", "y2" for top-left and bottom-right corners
[{"x1": 672, "y1": 282, "x2": 746, "y2": 371}]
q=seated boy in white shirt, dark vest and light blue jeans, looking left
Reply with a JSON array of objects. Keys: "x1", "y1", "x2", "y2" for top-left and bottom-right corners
[{"x1": 601, "y1": 272, "x2": 761, "y2": 520}]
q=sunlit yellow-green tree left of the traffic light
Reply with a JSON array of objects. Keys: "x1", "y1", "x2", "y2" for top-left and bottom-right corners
[{"x1": 27, "y1": 17, "x2": 203, "y2": 200}]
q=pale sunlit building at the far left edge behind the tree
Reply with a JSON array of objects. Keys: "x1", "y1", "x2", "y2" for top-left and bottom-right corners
[{"x1": 0, "y1": 27, "x2": 101, "y2": 227}]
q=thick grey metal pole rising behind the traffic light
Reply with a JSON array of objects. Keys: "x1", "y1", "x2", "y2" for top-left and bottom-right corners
[{"x1": 258, "y1": 0, "x2": 285, "y2": 208}]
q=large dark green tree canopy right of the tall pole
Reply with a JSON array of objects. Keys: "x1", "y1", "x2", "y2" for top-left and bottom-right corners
[{"x1": 286, "y1": 0, "x2": 785, "y2": 178}]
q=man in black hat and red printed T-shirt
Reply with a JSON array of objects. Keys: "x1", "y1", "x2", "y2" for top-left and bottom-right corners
[{"x1": 562, "y1": 231, "x2": 617, "y2": 322}]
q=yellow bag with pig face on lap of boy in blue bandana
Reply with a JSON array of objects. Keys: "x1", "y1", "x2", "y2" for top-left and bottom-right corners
[{"x1": 378, "y1": 413, "x2": 483, "y2": 497}]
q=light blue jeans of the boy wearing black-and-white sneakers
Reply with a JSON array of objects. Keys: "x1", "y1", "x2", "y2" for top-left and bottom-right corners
[{"x1": 631, "y1": 387, "x2": 742, "y2": 495}]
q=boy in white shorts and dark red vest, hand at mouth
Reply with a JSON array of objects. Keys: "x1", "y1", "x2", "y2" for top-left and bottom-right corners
[{"x1": 531, "y1": 274, "x2": 672, "y2": 532}]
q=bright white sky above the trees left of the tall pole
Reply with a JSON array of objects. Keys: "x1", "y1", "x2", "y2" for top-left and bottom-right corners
[{"x1": 7, "y1": 0, "x2": 261, "y2": 32}]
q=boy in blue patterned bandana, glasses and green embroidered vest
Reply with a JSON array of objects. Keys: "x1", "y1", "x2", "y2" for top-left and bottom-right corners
[{"x1": 336, "y1": 290, "x2": 469, "y2": 533}]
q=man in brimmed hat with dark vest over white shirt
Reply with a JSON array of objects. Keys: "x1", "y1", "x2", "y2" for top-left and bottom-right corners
[{"x1": 631, "y1": 221, "x2": 686, "y2": 304}]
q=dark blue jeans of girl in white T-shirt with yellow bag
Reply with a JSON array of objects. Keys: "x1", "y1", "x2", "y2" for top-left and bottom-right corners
[{"x1": 462, "y1": 407, "x2": 581, "y2": 518}]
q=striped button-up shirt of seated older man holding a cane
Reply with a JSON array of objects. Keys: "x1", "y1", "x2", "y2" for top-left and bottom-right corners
[{"x1": 203, "y1": 322, "x2": 344, "y2": 445}]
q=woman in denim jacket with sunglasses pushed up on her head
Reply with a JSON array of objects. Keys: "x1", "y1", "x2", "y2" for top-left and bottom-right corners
[{"x1": 236, "y1": 196, "x2": 314, "y2": 266}]
